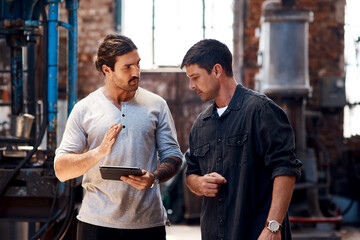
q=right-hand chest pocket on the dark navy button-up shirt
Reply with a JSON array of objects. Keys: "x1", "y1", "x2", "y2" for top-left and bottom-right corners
[{"x1": 226, "y1": 133, "x2": 248, "y2": 166}]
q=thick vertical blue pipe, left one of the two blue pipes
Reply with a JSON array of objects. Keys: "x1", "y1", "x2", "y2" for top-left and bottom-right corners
[{"x1": 47, "y1": 0, "x2": 61, "y2": 150}]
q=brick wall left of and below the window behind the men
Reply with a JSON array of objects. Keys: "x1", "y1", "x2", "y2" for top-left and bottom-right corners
[{"x1": 59, "y1": 0, "x2": 208, "y2": 152}]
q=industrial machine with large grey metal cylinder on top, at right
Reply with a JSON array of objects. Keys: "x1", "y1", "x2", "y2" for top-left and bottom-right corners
[{"x1": 257, "y1": 0, "x2": 345, "y2": 240}]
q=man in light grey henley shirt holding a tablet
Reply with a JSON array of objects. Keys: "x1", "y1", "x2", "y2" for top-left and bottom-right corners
[{"x1": 54, "y1": 35, "x2": 182, "y2": 240}]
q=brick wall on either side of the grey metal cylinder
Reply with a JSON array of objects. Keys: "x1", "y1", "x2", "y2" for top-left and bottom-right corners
[{"x1": 243, "y1": 0, "x2": 345, "y2": 165}]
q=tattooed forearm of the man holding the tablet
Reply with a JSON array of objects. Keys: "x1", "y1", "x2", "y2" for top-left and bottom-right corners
[{"x1": 155, "y1": 157, "x2": 182, "y2": 183}]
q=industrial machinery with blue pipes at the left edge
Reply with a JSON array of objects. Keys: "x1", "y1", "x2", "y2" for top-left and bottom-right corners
[{"x1": 0, "y1": 0, "x2": 79, "y2": 239}]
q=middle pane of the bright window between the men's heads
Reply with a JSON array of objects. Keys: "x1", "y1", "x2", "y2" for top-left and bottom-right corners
[{"x1": 154, "y1": 0, "x2": 202, "y2": 66}]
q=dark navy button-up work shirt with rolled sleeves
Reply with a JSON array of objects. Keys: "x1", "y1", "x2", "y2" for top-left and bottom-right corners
[{"x1": 186, "y1": 84, "x2": 302, "y2": 240}]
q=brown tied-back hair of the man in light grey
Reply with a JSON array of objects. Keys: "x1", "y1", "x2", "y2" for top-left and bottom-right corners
[{"x1": 95, "y1": 34, "x2": 137, "y2": 74}]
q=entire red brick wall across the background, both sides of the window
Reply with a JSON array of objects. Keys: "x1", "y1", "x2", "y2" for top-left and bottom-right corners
[{"x1": 60, "y1": 0, "x2": 345, "y2": 156}]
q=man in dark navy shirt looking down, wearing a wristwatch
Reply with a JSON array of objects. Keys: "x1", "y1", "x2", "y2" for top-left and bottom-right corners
[{"x1": 181, "y1": 39, "x2": 302, "y2": 240}]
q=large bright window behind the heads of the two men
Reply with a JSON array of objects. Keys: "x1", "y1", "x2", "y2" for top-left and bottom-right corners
[{"x1": 121, "y1": 0, "x2": 233, "y2": 69}]
